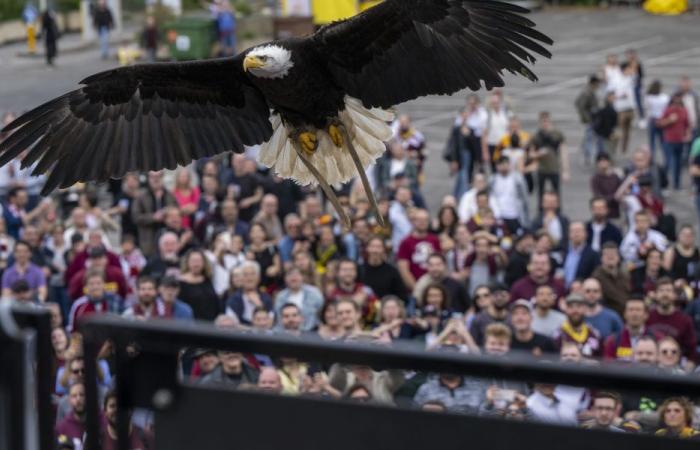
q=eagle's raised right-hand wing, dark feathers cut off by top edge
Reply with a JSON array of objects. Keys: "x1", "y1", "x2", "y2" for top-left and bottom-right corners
[{"x1": 306, "y1": 0, "x2": 552, "y2": 108}]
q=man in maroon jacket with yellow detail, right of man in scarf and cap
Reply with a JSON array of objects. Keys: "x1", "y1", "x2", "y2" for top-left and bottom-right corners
[{"x1": 603, "y1": 298, "x2": 655, "y2": 361}]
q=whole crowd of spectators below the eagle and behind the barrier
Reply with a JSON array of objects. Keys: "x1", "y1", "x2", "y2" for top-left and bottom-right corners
[{"x1": 0, "y1": 53, "x2": 700, "y2": 449}]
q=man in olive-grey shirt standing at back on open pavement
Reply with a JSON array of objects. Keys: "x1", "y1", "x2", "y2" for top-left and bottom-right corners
[{"x1": 530, "y1": 111, "x2": 569, "y2": 210}]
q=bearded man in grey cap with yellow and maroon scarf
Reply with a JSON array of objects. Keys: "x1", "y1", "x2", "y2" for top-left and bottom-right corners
[{"x1": 554, "y1": 294, "x2": 602, "y2": 358}]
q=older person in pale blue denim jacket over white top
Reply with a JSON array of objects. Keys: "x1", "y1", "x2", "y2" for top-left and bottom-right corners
[{"x1": 275, "y1": 268, "x2": 323, "y2": 331}]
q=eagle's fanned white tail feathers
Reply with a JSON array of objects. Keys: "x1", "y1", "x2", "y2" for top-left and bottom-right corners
[{"x1": 258, "y1": 97, "x2": 394, "y2": 186}]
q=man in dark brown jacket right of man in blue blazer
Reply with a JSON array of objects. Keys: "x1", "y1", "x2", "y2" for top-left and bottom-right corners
[{"x1": 593, "y1": 242, "x2": 631, "y2": 314}]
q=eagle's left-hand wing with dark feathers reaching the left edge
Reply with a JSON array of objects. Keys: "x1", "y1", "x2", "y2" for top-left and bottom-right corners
[{"x1": 0, "y1": 57, "x2": 272, "y2": 194}]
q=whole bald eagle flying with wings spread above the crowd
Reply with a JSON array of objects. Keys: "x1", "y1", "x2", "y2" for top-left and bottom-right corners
[{"x1": 0, "y1": 0, "x2": 552, "y2": 223}]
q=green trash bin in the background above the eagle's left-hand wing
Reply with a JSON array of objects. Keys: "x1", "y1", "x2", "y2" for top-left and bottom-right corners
[{"x1": 164, "y1": 17, "x2": 217, "y2": 61}]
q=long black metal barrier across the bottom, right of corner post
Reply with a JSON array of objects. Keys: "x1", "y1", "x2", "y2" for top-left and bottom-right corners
[{"x1": 81, "y1": 316, "x2": 700, "y2": 450}]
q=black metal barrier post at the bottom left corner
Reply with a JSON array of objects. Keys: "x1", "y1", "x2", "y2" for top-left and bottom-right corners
[{"x1": 0, "y1": 302, "x2": 53, "y2": 450}]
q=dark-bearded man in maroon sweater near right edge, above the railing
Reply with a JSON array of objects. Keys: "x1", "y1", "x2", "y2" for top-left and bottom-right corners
[{"x1": 647, "y1": 278, "x2": 697, "y2": 370}]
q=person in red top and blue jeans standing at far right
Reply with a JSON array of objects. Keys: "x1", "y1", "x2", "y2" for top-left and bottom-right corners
[{"x1": 656, "y1": 92, "x2": 692, "y2": 190}]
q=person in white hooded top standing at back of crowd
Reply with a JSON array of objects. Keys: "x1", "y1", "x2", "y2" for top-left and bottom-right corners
[{"x1": 489, "y1": 155, "x2": 530, "y2": 234}]
